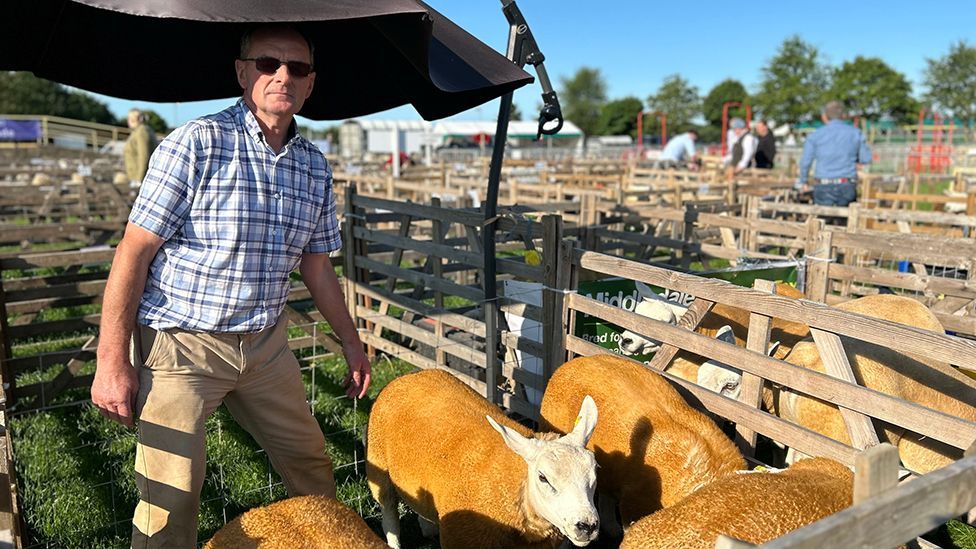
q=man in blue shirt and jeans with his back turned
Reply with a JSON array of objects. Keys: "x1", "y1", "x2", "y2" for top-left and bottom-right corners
[{"x1": 795, "y1": 101, "x2": 871, "y2": 206}]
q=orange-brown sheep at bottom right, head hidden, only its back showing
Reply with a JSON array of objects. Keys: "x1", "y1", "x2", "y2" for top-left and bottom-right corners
[{"x1": 620, "y1": 458, "x2": 854, "y2": 549}]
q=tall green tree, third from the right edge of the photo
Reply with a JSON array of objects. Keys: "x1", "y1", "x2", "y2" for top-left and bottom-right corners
[{"x1": 754, "y1": 36, "x2": 830, "y2": 123}]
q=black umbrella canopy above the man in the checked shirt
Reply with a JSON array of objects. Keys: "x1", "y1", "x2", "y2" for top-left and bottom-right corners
[{"x1": 0, "y1": 0, "x2": 532, "y2": 120}]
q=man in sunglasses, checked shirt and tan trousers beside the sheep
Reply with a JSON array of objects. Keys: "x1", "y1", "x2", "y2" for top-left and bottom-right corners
[{"x1": 92, "y1": 26, "x2": 370, "y2": 548}]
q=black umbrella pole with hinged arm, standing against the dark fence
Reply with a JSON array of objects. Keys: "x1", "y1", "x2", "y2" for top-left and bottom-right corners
[{"x1": 481, "y1": 0, "x2": 563, "y2": 404}]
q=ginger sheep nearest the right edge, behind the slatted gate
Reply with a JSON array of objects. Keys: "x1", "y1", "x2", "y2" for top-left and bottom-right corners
[{"x1": 699, "y1": 295, "x2": 976, "y2": 473}]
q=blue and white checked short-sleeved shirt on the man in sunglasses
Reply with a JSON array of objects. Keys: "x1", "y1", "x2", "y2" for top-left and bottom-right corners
[{"x1": 129, "y1": 101, "x2": 342, "y2": 333}]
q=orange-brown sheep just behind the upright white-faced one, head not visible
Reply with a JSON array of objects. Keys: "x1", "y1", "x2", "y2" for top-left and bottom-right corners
[{"x1": 540, "y1": 355, "x2": 746, "y2": 533}]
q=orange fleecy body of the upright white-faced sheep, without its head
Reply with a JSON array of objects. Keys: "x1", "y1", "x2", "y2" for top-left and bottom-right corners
[{"x1": 366, "y1": 370, "x2": 552, "y2": 547}]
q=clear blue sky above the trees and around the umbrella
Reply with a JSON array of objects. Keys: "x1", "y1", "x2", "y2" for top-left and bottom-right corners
[{"x1": 99, "y1": 0, "x2": 976, "y2": 127}]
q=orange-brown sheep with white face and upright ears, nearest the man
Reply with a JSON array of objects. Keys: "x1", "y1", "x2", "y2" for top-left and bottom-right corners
[{"x1": 366, "y1": 370, "x2": 599, "y2": 549}]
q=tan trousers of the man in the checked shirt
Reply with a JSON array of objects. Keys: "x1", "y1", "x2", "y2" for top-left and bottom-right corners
[{"x1": 132, "y1": 318, "x2": 335, "y2": 549}]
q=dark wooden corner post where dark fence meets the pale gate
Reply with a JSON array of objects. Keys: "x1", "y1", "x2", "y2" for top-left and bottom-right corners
[{"x1": 538, "y1": 215, "x2": 568, "y2": 391}]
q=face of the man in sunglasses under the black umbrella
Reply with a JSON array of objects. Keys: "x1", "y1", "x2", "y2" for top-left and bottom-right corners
[{"x1": 235, "y1": 29, "x2": 315, "y2": 120}]
